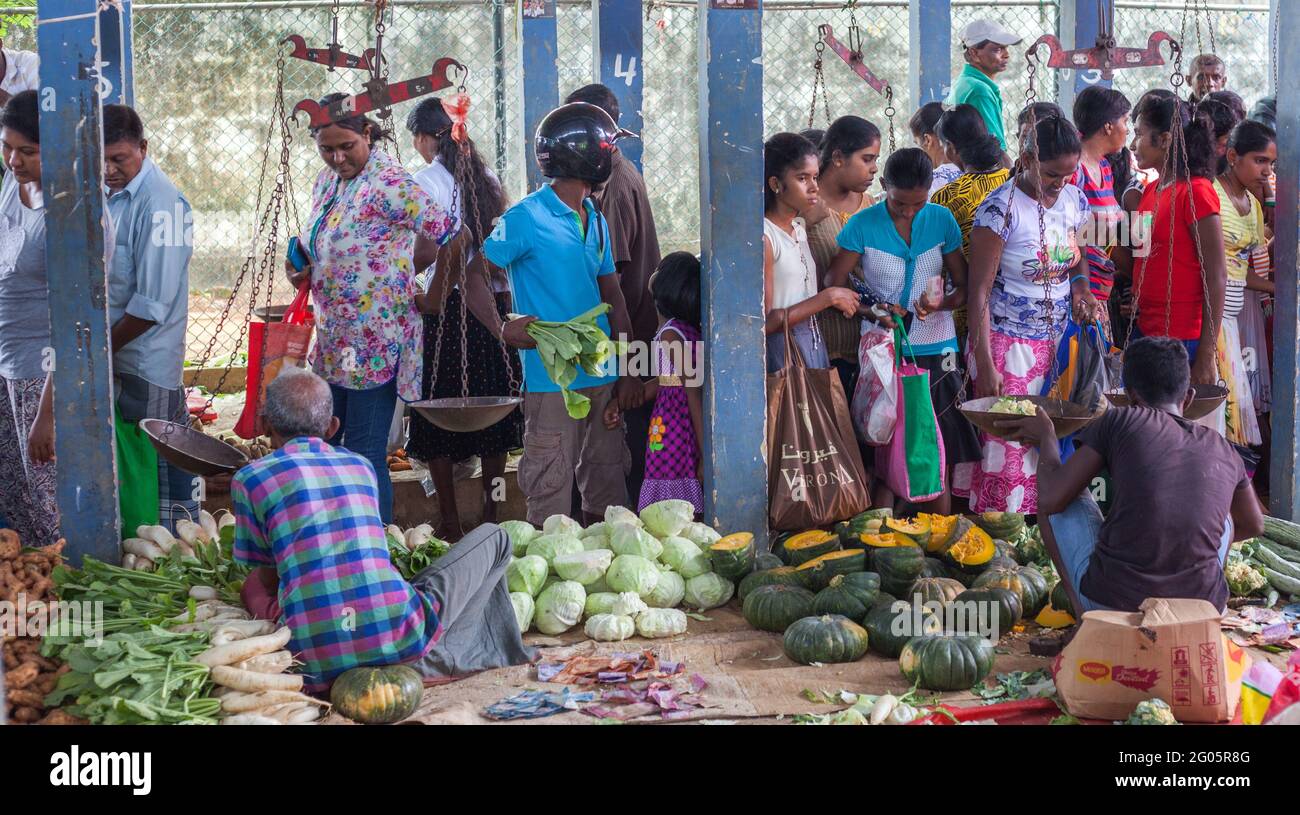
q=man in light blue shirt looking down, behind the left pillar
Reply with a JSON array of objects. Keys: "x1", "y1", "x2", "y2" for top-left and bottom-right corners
[{"x1": 104, "y1": 105, "x2": 198, "y2": 526}]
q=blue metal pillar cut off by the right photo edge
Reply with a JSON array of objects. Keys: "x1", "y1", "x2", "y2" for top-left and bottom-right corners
[{"x1": 1269, "y1": 3, "x2": 1300, "y2": 520}]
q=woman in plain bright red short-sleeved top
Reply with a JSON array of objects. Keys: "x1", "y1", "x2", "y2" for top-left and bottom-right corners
[{"x1": 1132, "y1": 95, "x2": 1227, "y2": 385}]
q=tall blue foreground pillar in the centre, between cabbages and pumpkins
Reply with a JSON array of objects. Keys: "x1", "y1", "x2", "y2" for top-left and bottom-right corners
[{"x1": 699, "y1": 0, "x2": 771, "y2": 547}]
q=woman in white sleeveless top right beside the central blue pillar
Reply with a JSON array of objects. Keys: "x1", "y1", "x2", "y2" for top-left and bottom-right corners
[{"x1": 763, "y1": 133, "x2": 858, "y2": 373}]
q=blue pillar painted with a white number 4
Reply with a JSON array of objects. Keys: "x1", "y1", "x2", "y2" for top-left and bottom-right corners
[{"x1": 592, "y1": 0, "x2": 645, "y2": 170}]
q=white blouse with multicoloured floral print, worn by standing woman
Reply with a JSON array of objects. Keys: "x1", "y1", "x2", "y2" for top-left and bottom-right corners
[{"x1": 299, "y1": 149, "x2": 459, "y2": 402}]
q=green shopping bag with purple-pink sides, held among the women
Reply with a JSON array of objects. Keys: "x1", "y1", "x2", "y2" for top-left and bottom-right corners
[{"x1": 876, "y1": 321, "x2": 946, "y2": 503}]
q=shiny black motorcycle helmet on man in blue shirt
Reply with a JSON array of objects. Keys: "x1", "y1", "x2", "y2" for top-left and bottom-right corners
[{"x1": 534, "y1": 101, "x2": 636, "y2": 185}]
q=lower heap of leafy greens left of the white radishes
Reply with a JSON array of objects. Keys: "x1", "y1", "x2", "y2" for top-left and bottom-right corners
[{"x1": 46, "y1": 625, "x2": 221, "y2": 724}]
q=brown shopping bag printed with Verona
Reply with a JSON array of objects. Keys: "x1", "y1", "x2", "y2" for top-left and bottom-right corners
[{"x1": 767, "y1": 315, "x2": 871, "y2": 530}]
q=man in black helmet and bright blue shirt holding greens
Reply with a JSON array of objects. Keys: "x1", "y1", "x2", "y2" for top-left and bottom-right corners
[{"x1": 484, "y1": 103, "x2": 641, "y2": 526}]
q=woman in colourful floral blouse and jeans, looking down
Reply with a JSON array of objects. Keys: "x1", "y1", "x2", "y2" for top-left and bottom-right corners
[{"x1": 286, "y1": 95, "x2": 458, "y2": 523}]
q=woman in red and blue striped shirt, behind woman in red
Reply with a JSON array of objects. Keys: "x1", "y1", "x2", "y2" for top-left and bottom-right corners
[{"x1": 1070, "y1": 86, "x2": 1132, "y2": 335}]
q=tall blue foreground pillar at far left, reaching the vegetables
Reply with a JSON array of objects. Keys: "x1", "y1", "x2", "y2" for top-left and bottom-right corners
[{"x1": 36, "y1": 0, "x2": 118, "y2": 563}]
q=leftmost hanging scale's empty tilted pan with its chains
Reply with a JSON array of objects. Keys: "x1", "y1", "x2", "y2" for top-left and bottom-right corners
[{"x1": 139, "y1": 39, "x2": 298, "y2": 477}]
